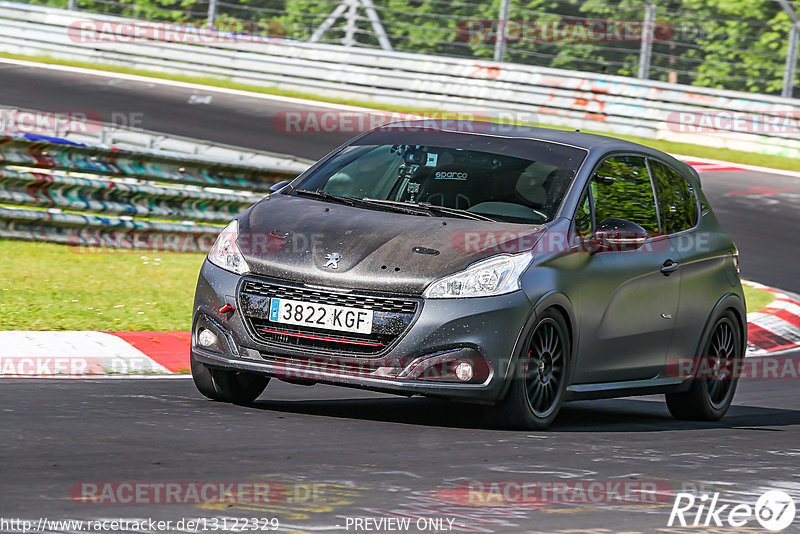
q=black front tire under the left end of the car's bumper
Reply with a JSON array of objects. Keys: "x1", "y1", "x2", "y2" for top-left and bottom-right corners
[{"x1": 191, "y1": 355, "x2": 269, "y2": 404}]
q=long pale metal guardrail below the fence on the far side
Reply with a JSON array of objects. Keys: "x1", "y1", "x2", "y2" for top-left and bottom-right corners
[{"x1": 0, "y1": 2, "x2": 800, "y2": 157}]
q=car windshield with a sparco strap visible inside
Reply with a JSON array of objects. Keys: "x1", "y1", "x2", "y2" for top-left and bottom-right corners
[{"x1": 294, "y1": 134, "x2": 585, "y2": 224}]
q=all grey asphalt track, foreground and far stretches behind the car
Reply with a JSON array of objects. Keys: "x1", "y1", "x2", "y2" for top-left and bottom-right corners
[{"x1": 0, "y1": 63, "x2": 800, "y2": 534}]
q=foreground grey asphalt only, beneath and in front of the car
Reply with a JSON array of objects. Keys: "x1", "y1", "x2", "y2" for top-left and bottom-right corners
[{"x1": 0, "y1": 372, "x2": 800, "y2": 534}]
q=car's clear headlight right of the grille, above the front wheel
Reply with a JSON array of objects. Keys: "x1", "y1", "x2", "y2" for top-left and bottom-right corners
[{"x1": 422, "y1": 252, "x2": 533, "y2": 299}]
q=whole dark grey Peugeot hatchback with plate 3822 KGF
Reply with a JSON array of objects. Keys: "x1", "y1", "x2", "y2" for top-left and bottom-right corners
[{"x1": 191, "y1": 121, "x2": 746, "y2": 428}]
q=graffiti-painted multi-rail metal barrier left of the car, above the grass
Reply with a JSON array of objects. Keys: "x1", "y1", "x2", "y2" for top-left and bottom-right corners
[{"x1": 0, "y1": 135, "x2": 306, "y2": 252}]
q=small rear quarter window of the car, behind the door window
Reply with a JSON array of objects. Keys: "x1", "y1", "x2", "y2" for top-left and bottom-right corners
[{"x1": 650, "y1": 160, "x2": 698, "y2": 234}]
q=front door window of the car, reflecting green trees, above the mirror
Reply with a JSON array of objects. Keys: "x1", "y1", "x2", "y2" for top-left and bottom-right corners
[{"x1": 591, "y1": 156, "x2": 658, "y2": 235}]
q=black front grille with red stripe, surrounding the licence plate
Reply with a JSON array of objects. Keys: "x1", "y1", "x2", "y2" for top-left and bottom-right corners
[{"x1": 239, "y1": 279, "x2": 419, "y2": 355}]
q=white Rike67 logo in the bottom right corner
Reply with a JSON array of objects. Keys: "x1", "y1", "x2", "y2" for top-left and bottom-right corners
[{"x1": 667, "y1": 490, "x2": 796, "y2": 532}]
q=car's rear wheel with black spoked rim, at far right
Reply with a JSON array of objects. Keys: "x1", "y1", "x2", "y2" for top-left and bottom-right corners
[{"x1": 666, "y1": 310, "x2": 744, "y2": 421}]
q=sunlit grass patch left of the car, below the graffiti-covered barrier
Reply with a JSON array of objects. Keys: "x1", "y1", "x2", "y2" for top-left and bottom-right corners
[{"x1": 0, "y1": 240, "x2": 203, "y2": 330}]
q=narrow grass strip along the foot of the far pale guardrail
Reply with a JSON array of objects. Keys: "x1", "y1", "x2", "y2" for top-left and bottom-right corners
[{"x1": 6, "y1": 53, "x2": 800, "y2": 171}]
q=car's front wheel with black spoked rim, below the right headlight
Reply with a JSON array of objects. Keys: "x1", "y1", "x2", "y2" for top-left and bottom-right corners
[{"x1": 497, "y1": 310, "x2": 571, "y2": 429}]
